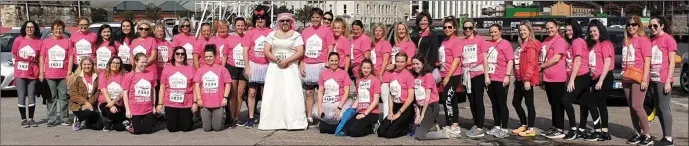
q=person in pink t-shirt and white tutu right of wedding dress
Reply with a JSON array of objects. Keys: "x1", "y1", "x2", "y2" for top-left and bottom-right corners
[{"x1": 299, "y1": 8, "x2": 339, "y2": 126}]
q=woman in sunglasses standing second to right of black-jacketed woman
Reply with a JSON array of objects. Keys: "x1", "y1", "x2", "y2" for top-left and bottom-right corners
[{"x1": 460, "y1": 20, "x2": 490, "y2": 137}]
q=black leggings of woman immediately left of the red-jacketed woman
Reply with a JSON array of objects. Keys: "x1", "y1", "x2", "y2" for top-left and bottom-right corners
[{"x1": 488, "y1": 81, "x2": 510, "y2": 129}]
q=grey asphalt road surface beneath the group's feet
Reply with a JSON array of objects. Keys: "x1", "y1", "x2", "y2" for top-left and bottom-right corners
[{"x1": 0, "y1": 82, "x2": 689, "y2": 145}]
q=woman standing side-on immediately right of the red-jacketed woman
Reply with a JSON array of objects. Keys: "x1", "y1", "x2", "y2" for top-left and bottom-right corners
[{"x1": 538, "y1": 20, "x2": 567, "y2": 139}]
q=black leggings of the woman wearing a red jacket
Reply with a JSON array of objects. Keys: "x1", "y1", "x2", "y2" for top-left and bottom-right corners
[{"x1": 512, "y1": 81, "x2": 536, "y2": 127}]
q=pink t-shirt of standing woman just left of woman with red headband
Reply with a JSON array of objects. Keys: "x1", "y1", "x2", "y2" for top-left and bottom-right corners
[{"x1": 223, "y1": 35, "x2": 249, "y2": 68}]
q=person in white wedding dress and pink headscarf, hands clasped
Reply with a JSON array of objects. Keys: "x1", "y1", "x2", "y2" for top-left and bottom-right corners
[{"x1": 258, "y1": 13, "x2": 307, "y2": 130}]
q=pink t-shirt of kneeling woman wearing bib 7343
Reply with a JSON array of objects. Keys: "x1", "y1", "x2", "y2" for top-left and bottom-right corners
[{"x1": 123, "y1": 71, "x2": 157, "y2": 115}]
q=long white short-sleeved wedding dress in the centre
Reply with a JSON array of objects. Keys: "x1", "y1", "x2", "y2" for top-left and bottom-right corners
[{"x1": 258, "y1": 30, "x2": 308, "y2": 130}]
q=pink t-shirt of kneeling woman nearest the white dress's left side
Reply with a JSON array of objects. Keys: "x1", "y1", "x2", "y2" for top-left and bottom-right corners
[{"x1": 194, "y1": 64, "x2": 232, "y2": 108}]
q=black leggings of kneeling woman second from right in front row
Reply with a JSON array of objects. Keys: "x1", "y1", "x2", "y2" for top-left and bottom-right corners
[{"x1": 378, "y1": 102, "x2": 414, "y2": 138}]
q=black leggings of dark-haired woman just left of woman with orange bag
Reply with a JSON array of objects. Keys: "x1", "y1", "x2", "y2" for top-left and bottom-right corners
[{"x1": 579, "y1": 72, "x2": 614, "y2": 129}]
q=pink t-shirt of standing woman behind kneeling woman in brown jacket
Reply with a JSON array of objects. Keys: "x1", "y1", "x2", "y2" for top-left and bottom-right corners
[{"x1": 69, "y1": 32, "x2": 97, "y2": 64}]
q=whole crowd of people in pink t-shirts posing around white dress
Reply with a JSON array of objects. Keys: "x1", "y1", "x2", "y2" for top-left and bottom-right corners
[{"x1": 12, "y1": 8, "x2": 677, "y2": 145}]
